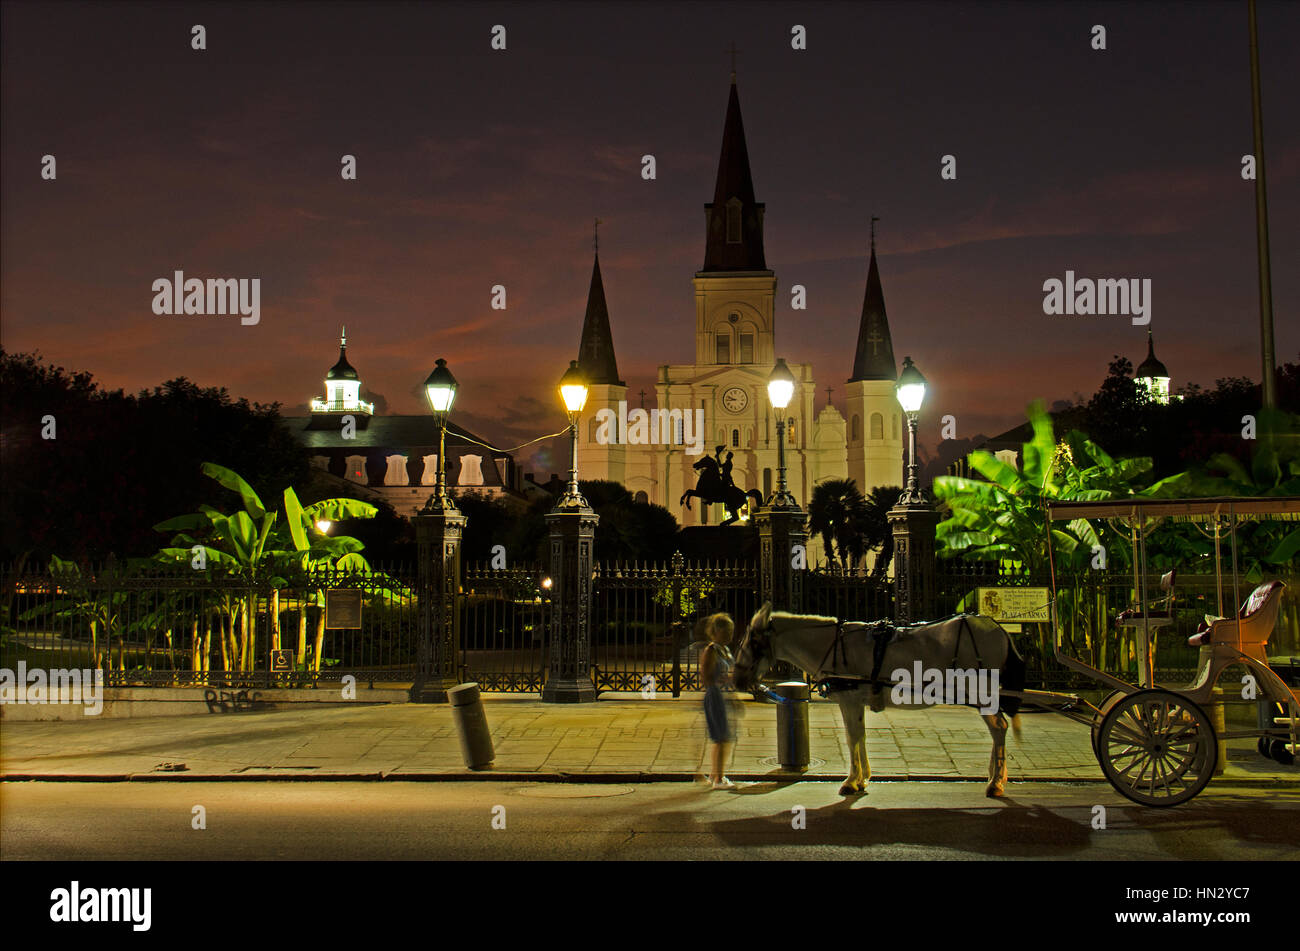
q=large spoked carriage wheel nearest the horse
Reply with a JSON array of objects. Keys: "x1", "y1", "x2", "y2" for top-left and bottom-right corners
[{"x1": 1097, "y1": 690, "x2": 1218, "y2": 805}]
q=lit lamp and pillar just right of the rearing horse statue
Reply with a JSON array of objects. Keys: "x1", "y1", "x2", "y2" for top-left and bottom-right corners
[{"x1": 754, "y1": 359, "x2": 807, "y2": 611}]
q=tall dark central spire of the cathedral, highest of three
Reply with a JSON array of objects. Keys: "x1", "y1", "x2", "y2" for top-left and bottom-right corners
[{"x1": 702, "y1": 71, "x2": 767, "y2": 272}]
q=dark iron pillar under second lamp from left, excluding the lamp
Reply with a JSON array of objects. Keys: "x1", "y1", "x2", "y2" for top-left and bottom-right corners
[{"x1": 542, "y1": 495, "x2": 601, "y2": 703}]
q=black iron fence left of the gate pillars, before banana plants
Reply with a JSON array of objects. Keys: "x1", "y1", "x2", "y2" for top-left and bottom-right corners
[{"x1": 0, "y1": 561, "x2": 419, "y2": 686}]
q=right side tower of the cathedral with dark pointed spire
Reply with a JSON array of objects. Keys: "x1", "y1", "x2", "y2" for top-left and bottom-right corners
[{"x1": 845, "y1": 235, "x2": 905, "y2": 495}]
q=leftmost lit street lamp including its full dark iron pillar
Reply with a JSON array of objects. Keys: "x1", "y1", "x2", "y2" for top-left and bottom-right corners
[{"x1": 411, "y1": 359, "x2": 465, "y2": 703}]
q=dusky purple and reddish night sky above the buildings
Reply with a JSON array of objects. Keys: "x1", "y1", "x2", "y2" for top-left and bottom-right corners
[{"x1": 0, "y1": 3, "x2": 1300, "y2": 474}]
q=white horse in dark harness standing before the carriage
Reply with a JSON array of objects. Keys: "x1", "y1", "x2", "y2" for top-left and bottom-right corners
[{"x1": 733, "y1": 602, "x2": 1024, "y2": 799}]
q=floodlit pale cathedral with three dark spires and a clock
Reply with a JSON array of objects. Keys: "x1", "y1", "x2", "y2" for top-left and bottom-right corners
[{"x1": 577, "y1": 73, "x2": 906, "y2": 535}]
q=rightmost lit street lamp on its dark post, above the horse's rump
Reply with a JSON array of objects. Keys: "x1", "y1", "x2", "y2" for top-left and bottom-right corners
[{"x1": 888, "y1": 357, "x2": 939, "y2": 624}]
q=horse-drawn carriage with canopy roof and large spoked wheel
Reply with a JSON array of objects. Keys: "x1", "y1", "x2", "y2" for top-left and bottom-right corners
[{"x1": 1034, "y1": 498, "x2": 1300, "y2": 805}]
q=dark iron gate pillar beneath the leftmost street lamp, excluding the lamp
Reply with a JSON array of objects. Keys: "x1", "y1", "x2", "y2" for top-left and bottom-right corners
[{"x1": 411, "y1": 496, "x2": 465, "y2": 703}]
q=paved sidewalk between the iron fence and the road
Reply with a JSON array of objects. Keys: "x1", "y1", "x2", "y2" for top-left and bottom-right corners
[{"x1": 0, "y1": 694, "x2": 1300, "y2": 785}]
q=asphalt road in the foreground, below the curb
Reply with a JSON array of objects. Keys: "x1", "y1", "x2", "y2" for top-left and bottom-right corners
[{"x1": 0, "y1": 782, "x2": 1300, "y2": 861}]
